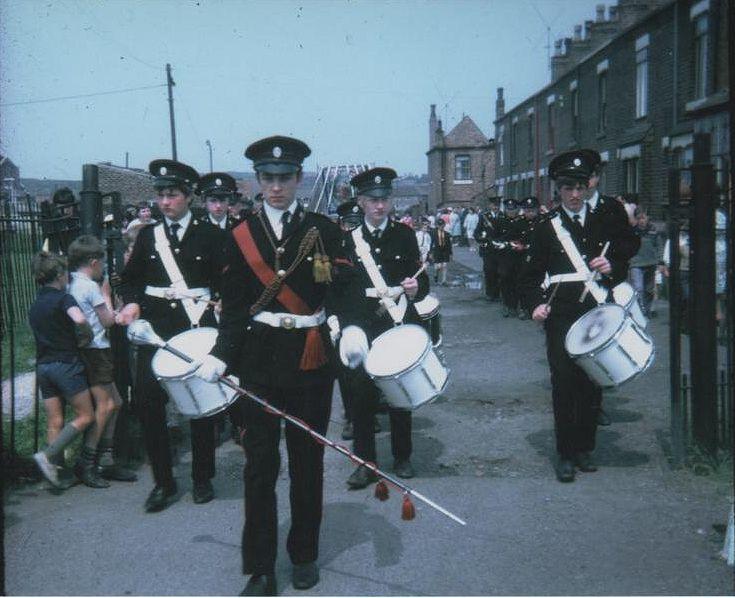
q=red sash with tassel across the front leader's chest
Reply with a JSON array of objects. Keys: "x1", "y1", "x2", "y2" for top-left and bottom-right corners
[{"x1": 232, "y1": 221, "x2": 327, "y2": 370}]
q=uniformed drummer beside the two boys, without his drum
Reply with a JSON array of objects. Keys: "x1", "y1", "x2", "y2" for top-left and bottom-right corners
[{"x1": 117, "y1": 160, "x2": 224, "y2": 513}]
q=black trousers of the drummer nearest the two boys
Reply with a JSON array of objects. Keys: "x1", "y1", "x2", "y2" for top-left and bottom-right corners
[{"x1": 136, "y1": 347, "x2": 215, "y2": 486}]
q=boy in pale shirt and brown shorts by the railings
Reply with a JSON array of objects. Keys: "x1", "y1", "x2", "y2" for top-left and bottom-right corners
[{"x1": 68, "y1": 235, "x2": 137, "y2": 488}]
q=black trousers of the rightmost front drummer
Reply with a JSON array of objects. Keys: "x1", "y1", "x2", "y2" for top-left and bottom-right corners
[{"x1": 545, "y1": 312, "x2": 602, "y2": 459}]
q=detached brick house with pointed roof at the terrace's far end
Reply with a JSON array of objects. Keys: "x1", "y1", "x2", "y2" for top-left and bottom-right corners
[{"x1": 426, "y1": 104, "x2": 495, "y2": 212}]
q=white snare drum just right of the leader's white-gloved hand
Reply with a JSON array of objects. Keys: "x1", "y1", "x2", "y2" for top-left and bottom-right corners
[{"x1": 365, "y1": 324, "x2": 449, "y2": 409}]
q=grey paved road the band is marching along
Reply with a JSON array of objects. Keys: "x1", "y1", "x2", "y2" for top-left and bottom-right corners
[{"x1": 5, "y1": 248, "x2": 733, "y2": 596}]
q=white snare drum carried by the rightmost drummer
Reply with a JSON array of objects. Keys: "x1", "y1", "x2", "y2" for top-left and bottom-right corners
[{"x1": 564, "y1": 303, "x2": 655, "y2": 388}]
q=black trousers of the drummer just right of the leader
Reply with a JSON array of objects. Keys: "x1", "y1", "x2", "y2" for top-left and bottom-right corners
[{"x1": 347, "y1": 366, "x2": 413, "y2": 462}]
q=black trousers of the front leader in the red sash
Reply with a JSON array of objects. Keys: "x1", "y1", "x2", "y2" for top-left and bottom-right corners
[{"x1": 238, "y1": 378, "x2": 334, "y2": 575}]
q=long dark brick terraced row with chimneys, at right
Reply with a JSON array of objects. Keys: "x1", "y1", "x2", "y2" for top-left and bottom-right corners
[{"x1": 495, "y1": 0, "x2": 731, "y2": 218}]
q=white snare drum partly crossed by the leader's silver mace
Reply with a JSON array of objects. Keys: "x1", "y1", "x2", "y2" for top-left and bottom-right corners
[{"x1": 151, "y1": 327, "x2": 238, "y2": 419}]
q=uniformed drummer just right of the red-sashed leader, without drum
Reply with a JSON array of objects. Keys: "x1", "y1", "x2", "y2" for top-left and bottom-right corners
[{"x1": 339, "y1": 168, "x2": 429, "y2": 489}]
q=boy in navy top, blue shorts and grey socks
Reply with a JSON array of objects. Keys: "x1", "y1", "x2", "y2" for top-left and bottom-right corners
[{"x1": 28, "y1": 251, "x2": 96, "y2": 488}]
